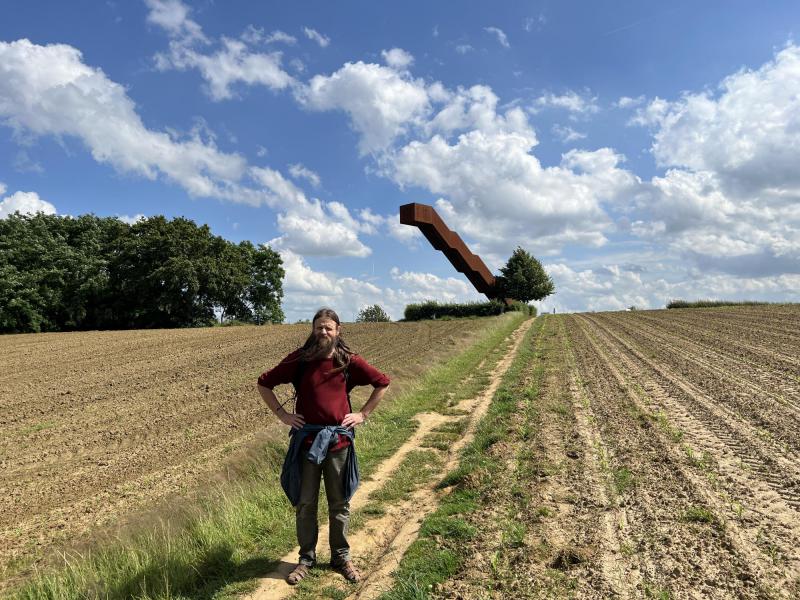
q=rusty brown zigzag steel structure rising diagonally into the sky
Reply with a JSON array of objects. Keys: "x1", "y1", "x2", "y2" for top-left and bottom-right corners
[{"x1": 400, "y1": 202, "x2": 497, "y2": 299}]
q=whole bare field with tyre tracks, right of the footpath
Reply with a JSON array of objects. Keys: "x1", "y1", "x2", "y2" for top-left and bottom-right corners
[{"x1": 382, "y1": 306, "x2": 800, "y2": 599}]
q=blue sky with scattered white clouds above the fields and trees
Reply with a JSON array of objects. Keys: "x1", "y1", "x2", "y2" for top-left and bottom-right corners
[{"x1": 0, "y1": 0, "x2": 800, "y2": 321}]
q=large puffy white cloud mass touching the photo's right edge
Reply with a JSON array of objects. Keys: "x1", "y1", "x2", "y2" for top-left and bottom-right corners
[{"x1": 633, "y1": 45, "x2": 800, "y2": 275}]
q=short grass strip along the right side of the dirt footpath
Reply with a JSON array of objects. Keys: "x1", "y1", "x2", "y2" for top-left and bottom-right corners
[{"x1": 380, "y1": 318, "x2": 545, "y2": 600}]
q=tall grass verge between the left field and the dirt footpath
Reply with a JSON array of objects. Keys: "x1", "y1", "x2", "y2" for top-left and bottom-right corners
[{"x1": 9, "y1": 313, "x2": 526, "y2": 600}]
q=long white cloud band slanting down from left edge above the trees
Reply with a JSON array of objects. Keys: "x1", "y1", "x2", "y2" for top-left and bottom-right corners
[{"x1": 0, "y1": 40, "x2": 378, "y2": 256}]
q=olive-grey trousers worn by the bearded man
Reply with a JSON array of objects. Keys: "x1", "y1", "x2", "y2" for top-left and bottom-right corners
[{"x1": 296, "y1": 447, "x2": 350, "y2": 565}]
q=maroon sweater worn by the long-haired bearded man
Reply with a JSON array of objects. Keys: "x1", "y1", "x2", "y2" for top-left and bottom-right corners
[{"x1": 258, "y1": 350, "x2": 389, "y2": 451}]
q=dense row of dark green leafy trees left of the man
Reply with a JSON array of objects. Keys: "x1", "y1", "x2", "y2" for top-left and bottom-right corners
[{"x1": 0, "y1": 213, "x2": 285, "y2": 333}]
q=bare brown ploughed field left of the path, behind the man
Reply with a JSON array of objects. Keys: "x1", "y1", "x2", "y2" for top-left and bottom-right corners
[{"x1": 0, "y1": 320, "x2": 496, "y2": 579}]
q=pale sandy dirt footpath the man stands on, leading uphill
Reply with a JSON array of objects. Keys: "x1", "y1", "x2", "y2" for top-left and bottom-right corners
[{"x1": 241, "y1": 319, "x2": 533, "y2": 600}]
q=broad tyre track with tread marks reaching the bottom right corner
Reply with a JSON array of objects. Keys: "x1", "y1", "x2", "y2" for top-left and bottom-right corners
[{"x1": 589, "y1": 318, "x2": 800, "y2": 590}]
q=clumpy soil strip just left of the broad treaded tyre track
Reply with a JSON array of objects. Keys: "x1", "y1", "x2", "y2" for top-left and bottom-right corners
[{"x1": 569, "y1": 316, "x2": 771, "y2": 598}]
